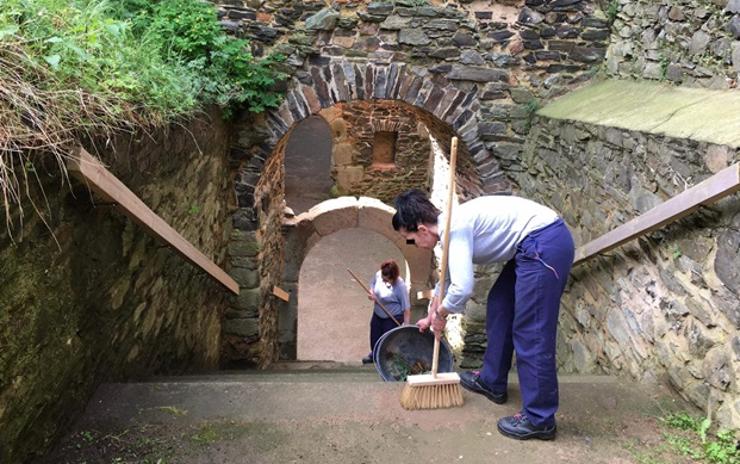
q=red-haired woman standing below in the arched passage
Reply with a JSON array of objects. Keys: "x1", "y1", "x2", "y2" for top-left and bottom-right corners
[{"x1": 362, "y1": 259, "x2": 411, "y2": 364}]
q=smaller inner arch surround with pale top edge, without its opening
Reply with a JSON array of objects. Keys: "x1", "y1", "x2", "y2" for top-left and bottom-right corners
[{"x1": 278, "y1": 197, "x2": 433, "y2": 359}]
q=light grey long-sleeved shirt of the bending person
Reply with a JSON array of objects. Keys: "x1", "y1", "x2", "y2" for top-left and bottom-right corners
[{"x1": 435, "y1": 196, "x2": 558, "y2": 313}]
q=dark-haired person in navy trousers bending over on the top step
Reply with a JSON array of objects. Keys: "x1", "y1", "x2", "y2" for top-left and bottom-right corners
[{"x1": 393, "y1": 190, "x2": 574, "y2": 440}]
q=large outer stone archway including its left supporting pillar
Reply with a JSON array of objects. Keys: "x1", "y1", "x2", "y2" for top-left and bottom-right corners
[{"x1": 222, "y1": 57, "x2": 510, "y2": 366}]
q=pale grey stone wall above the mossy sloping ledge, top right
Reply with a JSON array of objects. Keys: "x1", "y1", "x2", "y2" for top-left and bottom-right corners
[{"x1": 605, "y1": 0, "x2": 740, "y2": 89}]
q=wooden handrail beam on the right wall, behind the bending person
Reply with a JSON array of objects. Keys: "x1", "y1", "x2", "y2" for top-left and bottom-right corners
[{"x1": 574, "y1": 163, "x2": 740, "y2": 265}]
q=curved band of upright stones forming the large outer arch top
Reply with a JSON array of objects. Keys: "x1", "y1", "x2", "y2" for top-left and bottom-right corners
[{"x1": 263, "y1": 57, "x2": 510, "y2": 192}]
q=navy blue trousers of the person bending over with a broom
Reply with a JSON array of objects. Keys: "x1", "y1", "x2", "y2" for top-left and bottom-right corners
[{"x1": 480, "y1": 220, "x2": 574, "y2": 426}]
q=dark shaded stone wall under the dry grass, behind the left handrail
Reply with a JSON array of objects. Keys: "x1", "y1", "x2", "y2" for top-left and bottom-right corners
[{"x1": 0, "y1": 113, "x2": 232, "y2": 463}]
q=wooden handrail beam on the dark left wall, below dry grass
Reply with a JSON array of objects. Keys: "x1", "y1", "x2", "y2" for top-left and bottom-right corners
[{"x1": 67, "y1": 148, "x2": 239, "y2": 295}]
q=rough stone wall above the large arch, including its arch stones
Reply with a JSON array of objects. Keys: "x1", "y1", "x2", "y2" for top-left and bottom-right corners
[{"x1": 218, "y1": 0, "x2": 608, "y2": 191}]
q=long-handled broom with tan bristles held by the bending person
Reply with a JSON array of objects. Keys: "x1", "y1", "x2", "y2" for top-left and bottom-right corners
[{"x1": 401, "y1": 137, "x2": 463, "y2": 410}]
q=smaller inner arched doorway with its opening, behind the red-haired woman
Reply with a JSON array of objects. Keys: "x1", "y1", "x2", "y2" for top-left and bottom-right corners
[{"x1": 278, "y1": 197, "x2": 432, "y2": 362}]
